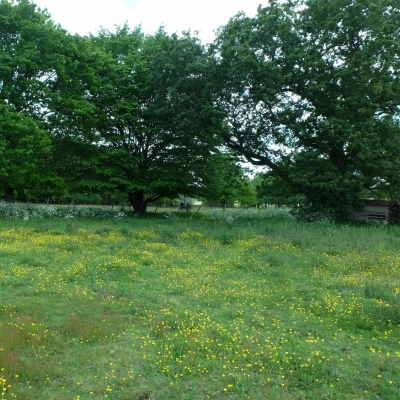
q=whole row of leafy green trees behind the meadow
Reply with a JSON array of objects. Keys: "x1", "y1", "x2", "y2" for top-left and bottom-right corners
[{"x1": 0, "y1": 0, "x2": 400, "y2": 220}]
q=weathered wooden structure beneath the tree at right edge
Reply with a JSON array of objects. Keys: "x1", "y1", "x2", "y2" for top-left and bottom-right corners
[{"x1": 353, "y1": 200, "x2": 400, "y2": 224}]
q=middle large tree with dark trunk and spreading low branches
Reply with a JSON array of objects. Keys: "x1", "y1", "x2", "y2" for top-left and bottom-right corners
[{"x1": 57, "y1": 26, "x2": 221, "y2": 213}]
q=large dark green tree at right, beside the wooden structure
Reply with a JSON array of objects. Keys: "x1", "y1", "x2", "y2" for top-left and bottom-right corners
[{"x1": 214, "y1": 0, "x2": 400, "y2": 219}]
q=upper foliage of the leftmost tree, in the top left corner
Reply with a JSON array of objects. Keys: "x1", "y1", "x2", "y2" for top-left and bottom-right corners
[{"x1": 0, "y1": 0, "x2": 65, "y2": 117}]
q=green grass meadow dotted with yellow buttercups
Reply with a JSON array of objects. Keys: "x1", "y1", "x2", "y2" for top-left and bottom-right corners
[{"x1": 0, "y1": 211, "x2": 400, "y2": 400}]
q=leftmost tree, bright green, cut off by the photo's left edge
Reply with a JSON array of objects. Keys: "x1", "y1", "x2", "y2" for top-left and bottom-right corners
[{"x1": 0, "y1": 0, "x2": 66, "y2": 202}]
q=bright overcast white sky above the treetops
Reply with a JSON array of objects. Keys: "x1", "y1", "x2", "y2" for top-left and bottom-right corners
[{"x1": 31, "y1": 0, "x2": 267, "y2": 43}]
